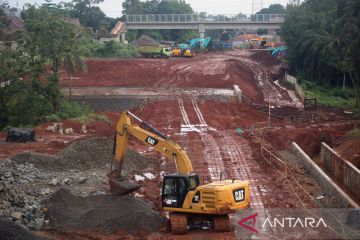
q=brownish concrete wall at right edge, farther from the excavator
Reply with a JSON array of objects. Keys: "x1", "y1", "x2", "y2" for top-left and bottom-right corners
[{"x1": 320, "y1": 143, "x2": 360, "y2": 204}]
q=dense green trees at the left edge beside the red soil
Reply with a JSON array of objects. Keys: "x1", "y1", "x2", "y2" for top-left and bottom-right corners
[{"x1": 0, "y1": 6, "x2": 87, "y2": 129}]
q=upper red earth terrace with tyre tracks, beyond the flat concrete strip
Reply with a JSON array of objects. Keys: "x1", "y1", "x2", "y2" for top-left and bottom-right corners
[{"x1": 61, "y1": 50, "x2": 299, "y2": 106}]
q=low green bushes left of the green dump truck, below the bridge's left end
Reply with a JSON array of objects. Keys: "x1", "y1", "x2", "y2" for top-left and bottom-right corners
[{"x1": 94, "y1": 41, "x2": 137, "y2": 58}]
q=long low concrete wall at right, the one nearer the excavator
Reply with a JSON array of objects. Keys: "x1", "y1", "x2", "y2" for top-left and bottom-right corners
[{"x1": 291, "y1": 142, "x2": 359, "y2": 208}]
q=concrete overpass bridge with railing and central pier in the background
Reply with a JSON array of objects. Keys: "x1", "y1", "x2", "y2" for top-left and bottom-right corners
[{"x1": 122, "y1": 14, "x2": 285, "y2": 38}]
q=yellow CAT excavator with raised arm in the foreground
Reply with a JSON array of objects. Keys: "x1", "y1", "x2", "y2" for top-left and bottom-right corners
[{"x1": 109, "y1": 111, "x2": 250, "y2": 234}]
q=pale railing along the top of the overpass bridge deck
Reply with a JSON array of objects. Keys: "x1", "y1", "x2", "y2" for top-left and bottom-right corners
[{"x1": 126, "y1": 14, "x2": 285, "y2": 24}]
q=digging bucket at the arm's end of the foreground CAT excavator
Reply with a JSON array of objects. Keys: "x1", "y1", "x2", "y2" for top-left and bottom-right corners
[{"x1": 109, "y1": 175, "x2": 140, "y2": 196}]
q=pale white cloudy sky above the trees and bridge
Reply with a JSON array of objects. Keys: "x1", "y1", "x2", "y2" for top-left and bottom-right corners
[{"x1": 7, "y1": 0, "x2": 289, "y2": 17}]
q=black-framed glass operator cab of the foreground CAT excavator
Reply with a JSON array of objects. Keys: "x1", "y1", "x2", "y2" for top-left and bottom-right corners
[{"x1": 161, "y1": 174, "x2": 200, "y2": 208}]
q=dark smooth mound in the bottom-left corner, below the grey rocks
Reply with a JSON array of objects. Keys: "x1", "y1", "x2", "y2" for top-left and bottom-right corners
[{"x1": 0, "y1": 217, "x2": 41, "y2": 240}]
